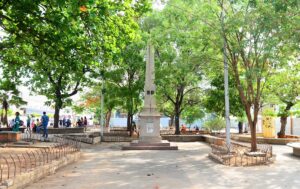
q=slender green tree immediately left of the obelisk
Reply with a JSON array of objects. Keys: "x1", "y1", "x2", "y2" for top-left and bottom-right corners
[{"x1": 105, "y1": 40, "x2": 145, "y2": 131}]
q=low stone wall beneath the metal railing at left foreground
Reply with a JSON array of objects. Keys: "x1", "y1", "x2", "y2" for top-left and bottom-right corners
[{"x1": 2, "y1": 152, "x2": 81, "y2": 189}]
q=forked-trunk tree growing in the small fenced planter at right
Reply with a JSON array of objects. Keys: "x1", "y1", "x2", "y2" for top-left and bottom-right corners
[{"x1": 209, "y1": 0, "x2": 298, "y2": 151}]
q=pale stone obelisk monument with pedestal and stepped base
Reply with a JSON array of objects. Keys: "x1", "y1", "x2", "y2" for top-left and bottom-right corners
[{"x1": 122, "y1": 44, "x2": 178, "y2": 150}]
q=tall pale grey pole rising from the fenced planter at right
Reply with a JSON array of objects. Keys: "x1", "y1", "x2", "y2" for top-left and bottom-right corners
[{"x1": 221, "y1": 0, "x2": 230, "y2": 146}]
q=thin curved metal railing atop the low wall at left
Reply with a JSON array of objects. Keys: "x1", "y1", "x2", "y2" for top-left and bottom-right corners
[{"x1": 0, "y1": 134, "x2": 80, "y2": 183}]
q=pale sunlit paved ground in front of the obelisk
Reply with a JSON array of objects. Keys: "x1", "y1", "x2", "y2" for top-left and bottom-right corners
[{"x1": 27, "y1": 142, "x2": 300, "y2": 189}]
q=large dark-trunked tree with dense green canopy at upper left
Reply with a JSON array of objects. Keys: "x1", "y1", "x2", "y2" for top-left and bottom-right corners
[{"x1": 0, "y1": 0, "x2": 148, "y2": 127}]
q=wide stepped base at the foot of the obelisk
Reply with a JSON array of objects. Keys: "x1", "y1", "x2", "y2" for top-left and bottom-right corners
[{"x1": 122, "y1": 140, "x2": 178, "y2": 150}]
